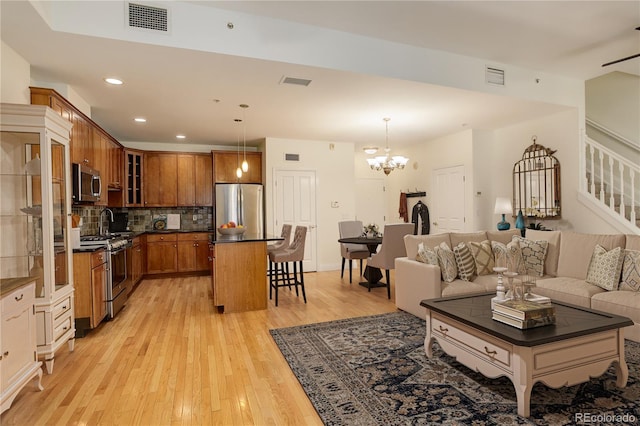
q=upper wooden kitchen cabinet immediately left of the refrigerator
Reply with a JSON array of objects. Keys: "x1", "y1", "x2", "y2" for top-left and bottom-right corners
[{"x1": 177, "y1": 154, "x2": 213, "y2": 206}]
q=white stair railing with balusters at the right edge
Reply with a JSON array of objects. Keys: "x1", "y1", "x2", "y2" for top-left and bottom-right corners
[{"x1": 580, "y1": 133, "x2": 640, "y2": 231}]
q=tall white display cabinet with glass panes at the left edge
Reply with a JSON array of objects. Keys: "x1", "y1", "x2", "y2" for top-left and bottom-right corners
[{"x1": 0, "y1": 103, "x2": 75, "y2": 374}]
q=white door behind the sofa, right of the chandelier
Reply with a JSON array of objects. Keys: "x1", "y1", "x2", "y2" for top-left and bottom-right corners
[{"x1": 431, "y1": 166, "x2": 465, "y2": 234}]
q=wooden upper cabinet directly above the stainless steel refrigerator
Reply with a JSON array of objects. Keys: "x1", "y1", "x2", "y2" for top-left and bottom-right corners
[{"x1": 213, "y1": 151, "x2": 262, "y2": 183}]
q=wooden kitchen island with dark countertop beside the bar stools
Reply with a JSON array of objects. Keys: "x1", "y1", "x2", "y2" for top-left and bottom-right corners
[{"x1": 209, "y1": 232, "x2": 282, "y2": 312}]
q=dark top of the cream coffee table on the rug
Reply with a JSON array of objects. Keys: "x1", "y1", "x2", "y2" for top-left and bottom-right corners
[{"x1": 420, "y1": 293, "x2": 633, "y2": 346}]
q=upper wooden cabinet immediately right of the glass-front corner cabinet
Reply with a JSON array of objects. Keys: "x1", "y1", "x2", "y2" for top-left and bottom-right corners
[{"x1": 143, "y1": 152, "x2": 178, "y2": 207}]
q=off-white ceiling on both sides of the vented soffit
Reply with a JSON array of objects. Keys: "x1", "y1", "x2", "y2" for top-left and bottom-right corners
[{"x1": 0, "y1": 0, "x2": 640, "y2": 147}]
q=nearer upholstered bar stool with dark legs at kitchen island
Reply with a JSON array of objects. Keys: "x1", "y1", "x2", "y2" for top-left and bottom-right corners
[{"x1": 269, "y1": 226, "x2": 307, "y2": 306}]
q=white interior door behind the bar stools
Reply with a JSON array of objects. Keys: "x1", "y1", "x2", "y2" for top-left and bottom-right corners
[{"x1": 273, "y1": 170, "x2": 318, "y2": 272}]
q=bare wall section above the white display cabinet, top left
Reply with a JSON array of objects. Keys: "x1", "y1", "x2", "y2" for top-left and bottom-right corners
[{"x1": 0, "y1": 41, "x2": 31, "y2": 104}]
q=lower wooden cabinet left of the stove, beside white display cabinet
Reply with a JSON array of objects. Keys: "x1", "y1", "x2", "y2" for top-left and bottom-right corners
[{"x1": 73, "y1": 249, "x2": 108, "y2": 337}]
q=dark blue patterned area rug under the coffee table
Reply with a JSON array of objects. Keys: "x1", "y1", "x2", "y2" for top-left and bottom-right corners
[{"x1": 271, "y1": 312, "x2": 640, "y2": 426}]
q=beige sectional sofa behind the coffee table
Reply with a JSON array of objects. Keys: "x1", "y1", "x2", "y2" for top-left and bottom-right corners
[{"x1": 395, "y1": 229, "x2": 640, "y2": 342}]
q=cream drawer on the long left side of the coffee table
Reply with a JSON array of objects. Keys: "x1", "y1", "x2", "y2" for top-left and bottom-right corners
[{"x1": 431, "y1": 317, "x2": 511, "y2": 369}]
